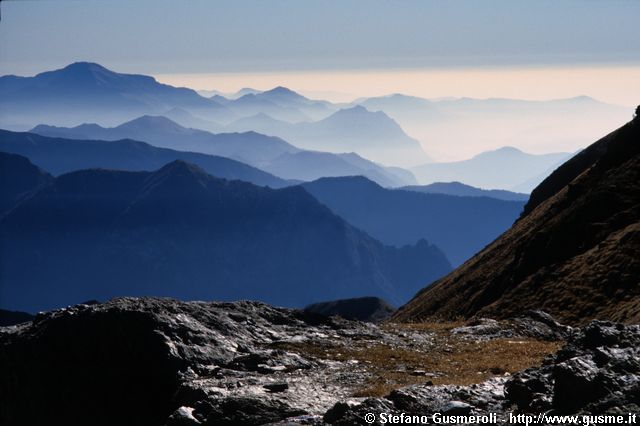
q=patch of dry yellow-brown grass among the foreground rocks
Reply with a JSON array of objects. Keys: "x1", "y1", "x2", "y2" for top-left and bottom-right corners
[{"x1": 270, "y1": 323, "x2": 561, "y2": 396}]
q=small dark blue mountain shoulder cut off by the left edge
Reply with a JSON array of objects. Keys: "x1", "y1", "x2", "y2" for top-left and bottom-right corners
[{"x1": 0, "y1": 152, "x2": 53, "y2": 217}]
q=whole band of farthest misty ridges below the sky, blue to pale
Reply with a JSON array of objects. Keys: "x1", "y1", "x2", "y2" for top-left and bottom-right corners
[{"x1": 0, "y1": 62, "x2": 628, "y2": 180}]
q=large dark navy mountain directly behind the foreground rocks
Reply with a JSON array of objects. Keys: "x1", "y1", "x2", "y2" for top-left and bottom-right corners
[{"x1": 0, "y1": 161, "x2": 451, "y2": 311}]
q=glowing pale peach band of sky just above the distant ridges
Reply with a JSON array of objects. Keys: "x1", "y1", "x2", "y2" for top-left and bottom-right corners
[{"x1": 156, "y1": 64, "x2": 640, "y2": 107}]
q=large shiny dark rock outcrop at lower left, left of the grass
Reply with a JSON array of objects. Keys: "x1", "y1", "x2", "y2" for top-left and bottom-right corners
[{"x1": 0, "y1": 298, "x2": 415, "y2": 426}]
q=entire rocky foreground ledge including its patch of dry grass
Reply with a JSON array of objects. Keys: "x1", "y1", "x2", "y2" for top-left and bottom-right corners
[{"x1": 0, "y1": 298, "x2": 640, "y2": 426}]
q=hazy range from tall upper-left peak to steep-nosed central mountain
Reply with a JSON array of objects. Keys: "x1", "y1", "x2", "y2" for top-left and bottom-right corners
[{"x1": 0, "y1": 62, "x2": 428, "y2": 165}]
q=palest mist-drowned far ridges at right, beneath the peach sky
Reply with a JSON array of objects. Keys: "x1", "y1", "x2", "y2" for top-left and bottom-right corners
[{"x1": 353, "y1": 94, "x2": 629, "y2": 163}]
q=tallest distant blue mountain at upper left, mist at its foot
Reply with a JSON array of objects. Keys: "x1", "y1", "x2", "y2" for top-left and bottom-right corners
[{"x1": 0, "y1": 62, "x2": 232, "y2": 126}]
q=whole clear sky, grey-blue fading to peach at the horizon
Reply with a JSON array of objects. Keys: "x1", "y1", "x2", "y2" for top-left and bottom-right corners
[{"x1": 0, "y1": 0, "x2": 640, "y2": 105}]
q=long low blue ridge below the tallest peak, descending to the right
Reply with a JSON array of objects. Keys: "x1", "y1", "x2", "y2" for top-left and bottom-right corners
[{"x1": 31, "y1": 116, "x2": 416, "y2": 187}]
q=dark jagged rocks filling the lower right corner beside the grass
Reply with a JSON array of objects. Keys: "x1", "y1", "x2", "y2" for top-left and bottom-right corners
[{"x1": 324, "y1": 321, "x2": 640, "y2": 425}]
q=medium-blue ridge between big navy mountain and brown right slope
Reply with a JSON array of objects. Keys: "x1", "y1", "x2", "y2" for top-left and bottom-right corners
[{"x1": 303, "y1": 177, "x2": 524, "y2": 266}]
